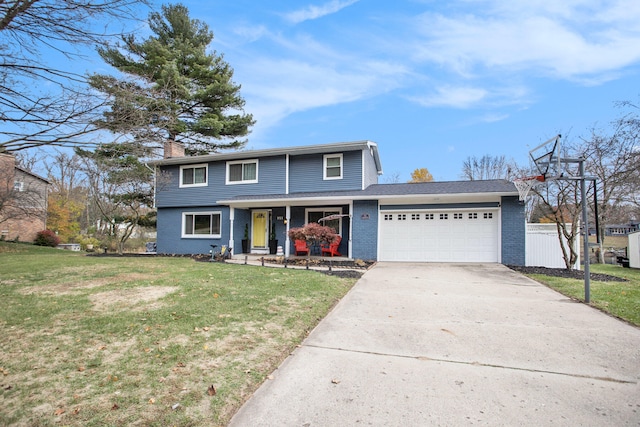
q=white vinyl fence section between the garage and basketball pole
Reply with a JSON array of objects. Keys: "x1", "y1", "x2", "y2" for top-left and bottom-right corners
[{"x1": 525, "y1": 224, "x2": 581, "y2": 270}]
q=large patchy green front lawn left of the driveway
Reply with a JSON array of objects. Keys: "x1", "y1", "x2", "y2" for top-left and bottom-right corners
[{"x1": 0, "y1": 242, "x2": 355, "y2": 426}]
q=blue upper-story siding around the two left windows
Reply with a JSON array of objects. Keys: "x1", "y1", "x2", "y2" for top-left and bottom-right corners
[{"x1": 156, "y1": 156, "x2": 286, "y2": 208}]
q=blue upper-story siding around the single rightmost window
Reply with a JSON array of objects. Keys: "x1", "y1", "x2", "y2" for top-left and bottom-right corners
[{"x1": 289, "y1": 151, "x2": 362, "y2": 193}]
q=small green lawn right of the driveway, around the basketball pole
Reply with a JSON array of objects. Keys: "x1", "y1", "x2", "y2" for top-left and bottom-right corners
[{"x1": 530, "y1": 264, "x2": 640, "y2": 326}]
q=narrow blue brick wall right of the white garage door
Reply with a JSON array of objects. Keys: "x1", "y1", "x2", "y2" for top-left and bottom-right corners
[{"x1": 502, "y1": 196, "x2": 527, "y2": 265}]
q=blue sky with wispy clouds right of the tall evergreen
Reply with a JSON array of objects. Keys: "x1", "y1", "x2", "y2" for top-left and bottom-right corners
[{"x1": 96, "y1": 0, "x2": 640, "y2": 182}]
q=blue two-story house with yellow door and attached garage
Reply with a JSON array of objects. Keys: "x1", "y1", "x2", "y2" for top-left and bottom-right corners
[{"x1": 155, "y1": 141, "x2": 526, "y2": 265}]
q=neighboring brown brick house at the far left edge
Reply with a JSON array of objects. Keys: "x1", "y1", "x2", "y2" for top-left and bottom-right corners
[{"x1": 0, "y1": 153, "x2": 49, "y2": 242}]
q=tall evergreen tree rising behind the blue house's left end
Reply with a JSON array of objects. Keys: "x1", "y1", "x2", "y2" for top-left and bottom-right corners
[{"x1": 90, "y1": 4, "x2": 254, "y2": 154}]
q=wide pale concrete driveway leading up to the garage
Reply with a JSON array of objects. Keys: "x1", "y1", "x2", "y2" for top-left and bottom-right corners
[{"x1": 230, "y1": 263, "x2": 640, "y2": 426}]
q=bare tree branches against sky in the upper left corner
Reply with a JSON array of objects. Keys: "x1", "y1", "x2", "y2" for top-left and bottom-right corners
[{"x1": 0, "y1": 0, "x2": 147, "y2": 151}]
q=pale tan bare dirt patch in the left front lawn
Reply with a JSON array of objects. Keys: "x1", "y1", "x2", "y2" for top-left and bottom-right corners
[{"x1": 89, "y1": 286, "x2": 178, "y2": 311}]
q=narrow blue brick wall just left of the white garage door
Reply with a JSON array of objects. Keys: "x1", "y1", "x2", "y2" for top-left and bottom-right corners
[{"x1": 351, "y1": 200, "x2": 378, "y2": 260}]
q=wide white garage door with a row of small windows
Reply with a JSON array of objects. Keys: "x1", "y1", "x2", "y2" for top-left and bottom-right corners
[{"x1": 379, "y1": 209, "x2": 499, "y2": 262}]
